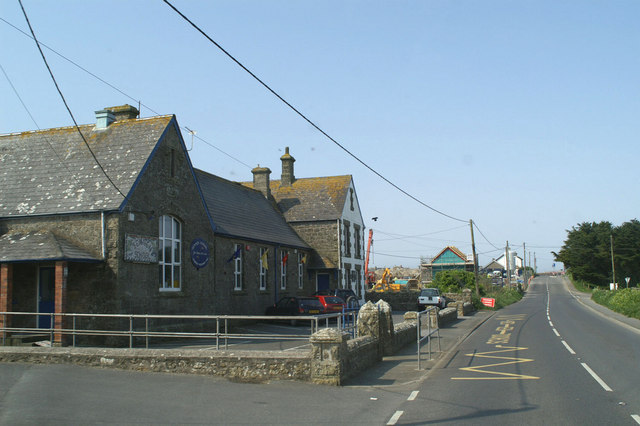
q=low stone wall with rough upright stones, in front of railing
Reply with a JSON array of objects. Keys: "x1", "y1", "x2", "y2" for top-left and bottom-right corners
[{"x1": 0, "y1": 300, "x2": 428, "y2": 386}]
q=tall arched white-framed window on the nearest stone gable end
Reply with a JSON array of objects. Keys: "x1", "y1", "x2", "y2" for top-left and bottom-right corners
[{"x1": 158, "y1": 215, "x2": 182, "y2": 291}]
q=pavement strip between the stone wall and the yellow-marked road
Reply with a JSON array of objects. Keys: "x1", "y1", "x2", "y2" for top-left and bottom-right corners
[{"x1": 343, "y1": 311, "x2": 495, "y2": 388}]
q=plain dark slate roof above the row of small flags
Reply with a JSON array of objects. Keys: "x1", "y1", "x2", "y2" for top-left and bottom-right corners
[{"x1": 195, "y1": 169, "x2": 309, "y2": 249}]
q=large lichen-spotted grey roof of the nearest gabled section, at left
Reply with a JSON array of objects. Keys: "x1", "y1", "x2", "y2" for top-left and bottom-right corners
[{"x1": 0, "y1": 115, "x2": 173, "y2": 218}]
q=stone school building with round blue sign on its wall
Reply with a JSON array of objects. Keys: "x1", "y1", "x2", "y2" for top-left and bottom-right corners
[{"x1": 0, "y1": 105, "x2": 364, "y2": 342}]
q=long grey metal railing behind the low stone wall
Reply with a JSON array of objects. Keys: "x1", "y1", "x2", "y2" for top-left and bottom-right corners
[{"x1": 0, "y1": 311, "x2": 357, "y2": 350}]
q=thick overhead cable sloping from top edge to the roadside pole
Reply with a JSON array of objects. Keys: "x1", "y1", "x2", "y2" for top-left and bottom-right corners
[{"x1": 163, "y1": 0, "x2": 467, "y2": 223}]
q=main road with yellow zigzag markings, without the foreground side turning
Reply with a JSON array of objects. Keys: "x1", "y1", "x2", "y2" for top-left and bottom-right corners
[{"x1": 387, "y1": 277, "x2": 640, "y2": 425}]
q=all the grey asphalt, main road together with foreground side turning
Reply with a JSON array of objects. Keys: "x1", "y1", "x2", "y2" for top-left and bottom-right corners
[{"x1": 0, "y1": 278, "x2": 640, "y2": 425}]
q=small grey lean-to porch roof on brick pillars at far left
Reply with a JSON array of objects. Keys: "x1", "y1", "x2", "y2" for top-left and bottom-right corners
[{"x1": 0, "y1": 231, "x2": 102, "y2": 262}]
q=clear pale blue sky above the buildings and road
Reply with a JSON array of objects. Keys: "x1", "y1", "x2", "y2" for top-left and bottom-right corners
[{"x1": 0, "y1": 0, "x2": 640, "y2": 271}]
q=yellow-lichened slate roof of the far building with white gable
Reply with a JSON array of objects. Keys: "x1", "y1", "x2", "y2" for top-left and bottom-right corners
[{"x1": 254, "y1": 175, "x2": 351, "y2": 222}]
